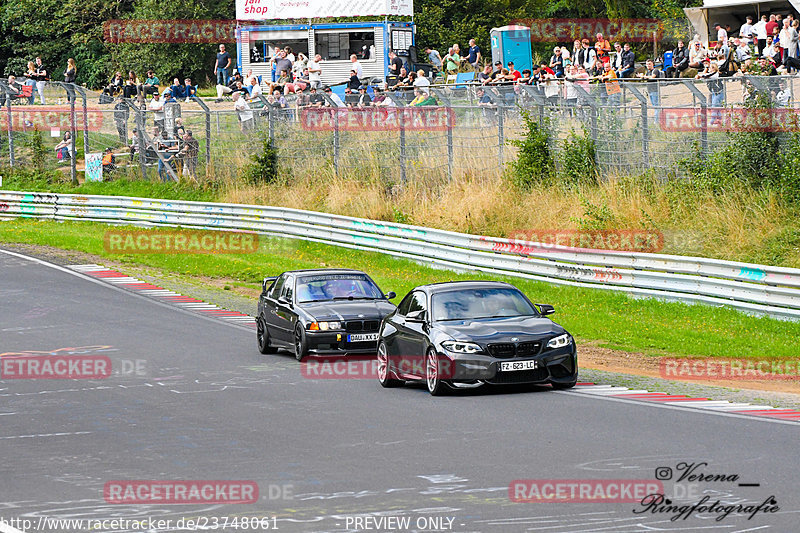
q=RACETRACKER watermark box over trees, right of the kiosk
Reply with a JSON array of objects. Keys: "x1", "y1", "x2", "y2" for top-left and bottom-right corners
[{"x1": 512, "y1": 18, "x2": 663, "y2": 44}]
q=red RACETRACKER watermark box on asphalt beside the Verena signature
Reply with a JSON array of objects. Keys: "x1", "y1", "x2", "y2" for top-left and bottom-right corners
[{"x1": 508, "y1": 479, "x2": 664, "y2": 503}]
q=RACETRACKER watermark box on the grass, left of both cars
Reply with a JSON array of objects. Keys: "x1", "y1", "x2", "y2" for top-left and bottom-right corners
[{"x1": 103, "y1": 230, "x2": 258, "y2": 254}]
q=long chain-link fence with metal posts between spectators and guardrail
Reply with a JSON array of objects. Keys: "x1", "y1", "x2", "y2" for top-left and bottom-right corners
[{"x1": 0, "y1": 76, "x2": 800, "y2": 183}]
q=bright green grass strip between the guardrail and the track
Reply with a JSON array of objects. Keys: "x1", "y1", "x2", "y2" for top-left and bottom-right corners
[{"x1": 0, "y1": 219, "x2": 800, "y2": 359}]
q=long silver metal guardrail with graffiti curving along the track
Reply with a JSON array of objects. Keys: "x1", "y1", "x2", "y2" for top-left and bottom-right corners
[{"x1": 0, "y1": 191, "x2": 800, "y2": 319}]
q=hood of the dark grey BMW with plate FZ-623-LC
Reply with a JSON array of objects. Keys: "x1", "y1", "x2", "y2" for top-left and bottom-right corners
[{"x1": 436, "y1": 316, "x2": 566, "y2": 343}]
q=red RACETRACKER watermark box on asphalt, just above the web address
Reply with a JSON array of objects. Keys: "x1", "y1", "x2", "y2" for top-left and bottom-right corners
[{"x1": 103, "y1": 480, "x2": 258, "y2": 505}]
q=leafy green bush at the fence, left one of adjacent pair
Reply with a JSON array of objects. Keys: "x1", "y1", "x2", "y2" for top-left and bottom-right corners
[{"x1": 508, "y1": 109, "x2": 555, "y2": 190}]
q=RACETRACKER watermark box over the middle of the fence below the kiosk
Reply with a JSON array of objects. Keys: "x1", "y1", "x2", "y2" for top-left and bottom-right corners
[{"x1": 300, "y1": 107, "x2": 456, "y2": 131}]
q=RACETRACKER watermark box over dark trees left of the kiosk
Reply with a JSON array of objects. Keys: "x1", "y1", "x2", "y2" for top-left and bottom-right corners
[{"x1": 103, "y1": 19, "x2": 236, "y2": 44}]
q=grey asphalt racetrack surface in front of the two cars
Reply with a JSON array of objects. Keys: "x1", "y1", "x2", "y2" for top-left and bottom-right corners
[{"x1": 0, "y1": 247, "x2": 800, "y2": 533}]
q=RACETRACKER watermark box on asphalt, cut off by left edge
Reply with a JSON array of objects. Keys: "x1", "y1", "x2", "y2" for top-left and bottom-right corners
[{"x1": 0, "y1": 355, "x2": 111, "y2": 379}]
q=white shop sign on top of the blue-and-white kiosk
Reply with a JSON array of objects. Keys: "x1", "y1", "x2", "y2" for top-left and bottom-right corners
[{"x1": 236, "y1": 0, "x2": 414, "y2": 20}]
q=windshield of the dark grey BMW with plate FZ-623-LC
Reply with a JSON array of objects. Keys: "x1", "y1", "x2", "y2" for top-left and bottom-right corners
[{"x1": 431, "y1": 288, "x2": 538, "y2": 320}]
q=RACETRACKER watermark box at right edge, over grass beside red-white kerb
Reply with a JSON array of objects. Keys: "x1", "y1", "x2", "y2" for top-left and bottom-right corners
[{"x1": 659, "y1": 358, "x2": 800, "y2": 381}]
